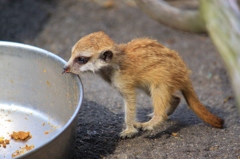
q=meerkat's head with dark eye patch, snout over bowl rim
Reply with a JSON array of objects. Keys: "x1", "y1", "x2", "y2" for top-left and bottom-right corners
[{"x1": 63, "y1": 31, "x2": 115, "y2": 74}]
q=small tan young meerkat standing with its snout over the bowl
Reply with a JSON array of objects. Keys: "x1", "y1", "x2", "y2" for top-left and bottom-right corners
[{"x1": 63, "y1": 31, "x2": 224, "y2": 138}]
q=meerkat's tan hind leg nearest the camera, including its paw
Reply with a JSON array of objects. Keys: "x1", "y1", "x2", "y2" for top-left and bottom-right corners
[{"x1": 139, "y1": 87, "x2": 172, "y2": 130}]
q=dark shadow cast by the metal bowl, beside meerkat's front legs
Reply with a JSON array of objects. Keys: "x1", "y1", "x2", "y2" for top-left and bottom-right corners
[{"x1": 75, "y1": 100, "x2": 123, "y2": 158}]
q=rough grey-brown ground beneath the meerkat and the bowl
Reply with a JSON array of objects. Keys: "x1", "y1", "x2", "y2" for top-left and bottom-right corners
[{"x1": 0, "y1": 0, "x2": 240, "y2": 159}]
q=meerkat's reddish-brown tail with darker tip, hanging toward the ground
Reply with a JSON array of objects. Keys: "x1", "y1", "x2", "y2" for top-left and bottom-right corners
[{"x1": 182, "y1": 83, "x2": 224, "y2": 128}]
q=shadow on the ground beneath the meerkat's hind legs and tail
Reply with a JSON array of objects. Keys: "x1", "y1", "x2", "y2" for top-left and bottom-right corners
[{"x1": 138, "y1": 104, "x2": 226, "y2": 139}]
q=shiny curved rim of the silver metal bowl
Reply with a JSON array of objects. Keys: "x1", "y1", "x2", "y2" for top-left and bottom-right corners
[{"x1": 0, "y1": 41, "x2": 84, "y2": 159}]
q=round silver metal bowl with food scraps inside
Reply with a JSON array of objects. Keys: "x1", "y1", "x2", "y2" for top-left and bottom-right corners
[{"x1": 0, "y1": 42, "x2": 83, "y2": 159}]
